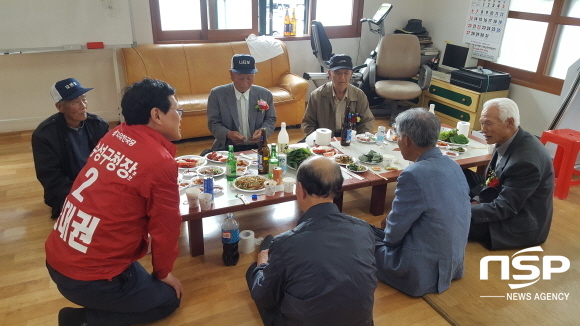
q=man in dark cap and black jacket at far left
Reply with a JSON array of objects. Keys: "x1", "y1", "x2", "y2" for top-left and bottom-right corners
[{"x1": 32, "y1": 78, "x2": 109, "y2": 219}]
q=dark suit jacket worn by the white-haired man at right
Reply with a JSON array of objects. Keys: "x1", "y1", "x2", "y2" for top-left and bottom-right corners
[{"x1": 471, "y1": 128, "x2": 554, "y2": 250}]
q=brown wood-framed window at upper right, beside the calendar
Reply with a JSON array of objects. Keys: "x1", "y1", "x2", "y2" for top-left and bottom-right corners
[{"x1": 480, "y1": 0, "x2": 580, "y2": 95}]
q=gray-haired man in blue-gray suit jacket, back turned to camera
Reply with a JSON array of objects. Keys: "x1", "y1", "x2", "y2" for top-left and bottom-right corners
[{"x1": 375, "y1": 108, "x2": 471, "y2": 296}]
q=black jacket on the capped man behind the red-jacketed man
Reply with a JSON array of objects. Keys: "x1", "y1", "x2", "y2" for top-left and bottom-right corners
[{"x1": 32, "y1": 113, "x2": 109, "y2": 209}]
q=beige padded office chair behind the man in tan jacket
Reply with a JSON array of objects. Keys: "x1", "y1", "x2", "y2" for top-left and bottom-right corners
[{"x1": 369, "y1": 34, "x2": 431, "y2": 114}]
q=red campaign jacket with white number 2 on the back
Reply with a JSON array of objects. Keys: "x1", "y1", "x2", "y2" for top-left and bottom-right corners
[{"x1": 45, "y1": 123, "x2": 181, "y2": 281}]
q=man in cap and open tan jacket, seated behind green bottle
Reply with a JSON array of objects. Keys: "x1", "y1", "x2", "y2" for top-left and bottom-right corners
[{"x1": 302, "y1": 54, "x2": 375, "y2": 137}]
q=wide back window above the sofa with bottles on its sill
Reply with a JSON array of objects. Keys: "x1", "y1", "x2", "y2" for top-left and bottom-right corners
[{"x1": 150, "y1": 0, "x2": 364, "y2": 43}]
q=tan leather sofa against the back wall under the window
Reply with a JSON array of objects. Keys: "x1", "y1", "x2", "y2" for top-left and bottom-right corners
[{"x1": 122, "y1": 42, "x2": 308, "y2": 139}]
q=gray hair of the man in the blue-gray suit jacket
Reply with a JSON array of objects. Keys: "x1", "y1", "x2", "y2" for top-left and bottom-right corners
[{"x1": 396, "y1": 108, "x2": 441, "y2": 148}]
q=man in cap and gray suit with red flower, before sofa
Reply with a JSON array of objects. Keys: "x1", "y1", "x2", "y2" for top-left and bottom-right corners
[{"x1": 207, "y1": 54, "x2": 276, "y2": 151}]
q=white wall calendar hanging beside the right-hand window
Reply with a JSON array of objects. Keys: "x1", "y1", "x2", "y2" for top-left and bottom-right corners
[{"x1": 463, "y1": 0, "x2": 510, "y2": 62}]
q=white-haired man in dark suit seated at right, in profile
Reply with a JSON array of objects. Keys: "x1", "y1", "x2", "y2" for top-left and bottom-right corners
[{"x1": 464, "y1": 98, "x2": 554, "y2": 250}]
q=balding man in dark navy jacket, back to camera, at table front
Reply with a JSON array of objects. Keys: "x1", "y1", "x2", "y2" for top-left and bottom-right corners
[{"x1": 246, "y1": 156, "x2": 377, "y2": 326}]
